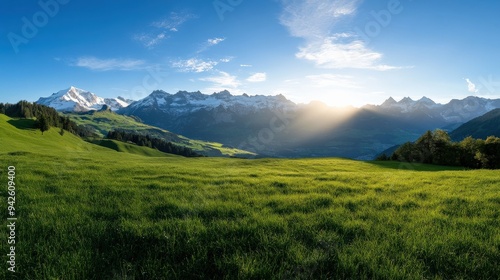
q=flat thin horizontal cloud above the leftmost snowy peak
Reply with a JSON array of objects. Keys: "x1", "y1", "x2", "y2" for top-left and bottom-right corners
[{"x1": 73, "y1": 57, "x2": 145, "y2": 71}]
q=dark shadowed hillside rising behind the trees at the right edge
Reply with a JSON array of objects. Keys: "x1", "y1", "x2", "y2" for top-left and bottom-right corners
[{"x1": 450, "y1": 109, "x2": 500, "y2": 141}]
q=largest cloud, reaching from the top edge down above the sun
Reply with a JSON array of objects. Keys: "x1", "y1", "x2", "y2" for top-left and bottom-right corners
[{"x1": 280, "y1": 0, "x2": 402, "y2": 71}]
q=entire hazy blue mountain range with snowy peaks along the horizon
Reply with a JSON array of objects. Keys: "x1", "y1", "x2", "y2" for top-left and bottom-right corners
[{"x1": 37, "y1": 87, "x2": 500, "y2": 159}]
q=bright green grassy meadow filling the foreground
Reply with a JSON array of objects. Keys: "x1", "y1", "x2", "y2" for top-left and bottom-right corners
[{"x1": 0, "y1": 115, "x2": 500, "y2": 279}]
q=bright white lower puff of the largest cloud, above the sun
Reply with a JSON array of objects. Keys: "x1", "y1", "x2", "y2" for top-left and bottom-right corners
[{"x1": 296, "y1": 34, "x2": 400, "y2": 71}]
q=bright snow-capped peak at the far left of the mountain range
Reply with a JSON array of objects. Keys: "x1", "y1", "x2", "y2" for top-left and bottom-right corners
[{"x1": 36, "y1": 86, "x2": 132, "y2": 112}]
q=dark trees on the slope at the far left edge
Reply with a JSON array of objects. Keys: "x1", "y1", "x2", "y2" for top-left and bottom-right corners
[{"x1": 0, "y1": 101, "x2": 95, "y2": 138}]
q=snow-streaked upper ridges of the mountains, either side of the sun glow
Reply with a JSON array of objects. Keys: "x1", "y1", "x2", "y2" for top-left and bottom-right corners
[{"x1": 36, "y1": 86, "x2": 500, "y2": 126}]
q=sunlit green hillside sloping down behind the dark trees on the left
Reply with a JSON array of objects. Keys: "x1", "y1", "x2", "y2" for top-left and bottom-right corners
[{"x1": 65, "y1": 111, "x2": 255, "y2": 157}]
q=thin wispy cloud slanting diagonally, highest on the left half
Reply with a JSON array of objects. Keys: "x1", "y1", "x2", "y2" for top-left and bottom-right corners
[{"x1": 133, "y1": 12, "x2": 196, "y2": 49}]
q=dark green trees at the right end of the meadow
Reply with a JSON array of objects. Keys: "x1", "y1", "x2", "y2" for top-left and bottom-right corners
[{"x1": 378, "y1": 129, "x2": 500, "y2": 169}]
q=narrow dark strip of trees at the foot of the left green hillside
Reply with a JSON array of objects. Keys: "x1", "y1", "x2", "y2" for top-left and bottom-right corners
[{"x1": 107, "y1": 130, "x2": 202, "y2": 157}]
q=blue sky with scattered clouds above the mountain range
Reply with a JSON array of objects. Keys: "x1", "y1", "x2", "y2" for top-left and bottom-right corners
[{"x1": 0, "y1": 0, "x2": 500, "y2": 106}]
